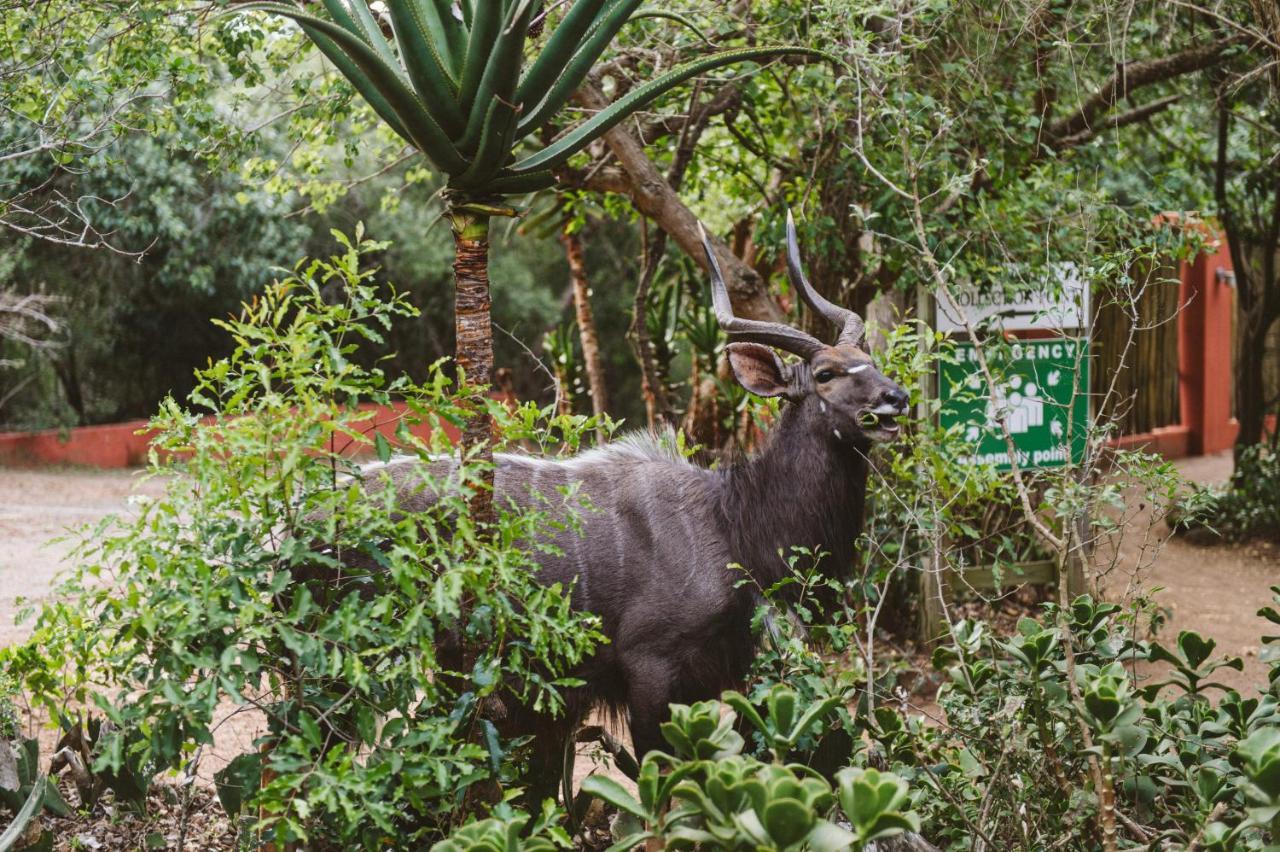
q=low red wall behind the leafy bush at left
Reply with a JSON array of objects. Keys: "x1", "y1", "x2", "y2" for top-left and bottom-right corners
[{"x1": 0, "y1": 403, "x2": 471, "y2": 468}]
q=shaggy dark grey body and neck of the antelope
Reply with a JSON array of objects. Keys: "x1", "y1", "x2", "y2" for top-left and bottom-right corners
[{"x1": 371, "y1": 394, "x2": 869, "y2": 756}]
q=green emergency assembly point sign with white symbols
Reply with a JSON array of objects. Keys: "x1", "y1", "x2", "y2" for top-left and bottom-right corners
[{"x1": 938, "y1": 338, "x2": 1089, "y2": 471}]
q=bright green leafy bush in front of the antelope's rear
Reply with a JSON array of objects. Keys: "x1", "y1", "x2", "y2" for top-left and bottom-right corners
[{"x1": 3, "y1": 230, "x2": 600, "y2": 846}]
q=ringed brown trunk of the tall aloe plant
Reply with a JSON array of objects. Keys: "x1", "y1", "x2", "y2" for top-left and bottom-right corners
[{"x1": 448, "y1": 203, "x2": 494, "y2": 523}]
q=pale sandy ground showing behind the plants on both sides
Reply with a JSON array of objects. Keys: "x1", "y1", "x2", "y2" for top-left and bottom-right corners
[{"x1": 0, "y1": 454, "x2": 1280, "y2": 780}]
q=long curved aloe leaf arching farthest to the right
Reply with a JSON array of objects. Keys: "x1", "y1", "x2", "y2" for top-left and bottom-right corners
[{"x1": 511, "y1": 46, "x2": 835, "y2": 174}]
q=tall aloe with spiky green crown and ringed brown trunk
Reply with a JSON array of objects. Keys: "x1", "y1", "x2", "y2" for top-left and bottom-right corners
[{"x1": 237, "y1": 0, "x2": 822, "y2": 504}]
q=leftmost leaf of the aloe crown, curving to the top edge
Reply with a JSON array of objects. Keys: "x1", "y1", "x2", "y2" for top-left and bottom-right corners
[{"x1": 234, "y1": 3, "x2": 467, "y2": 174}]
